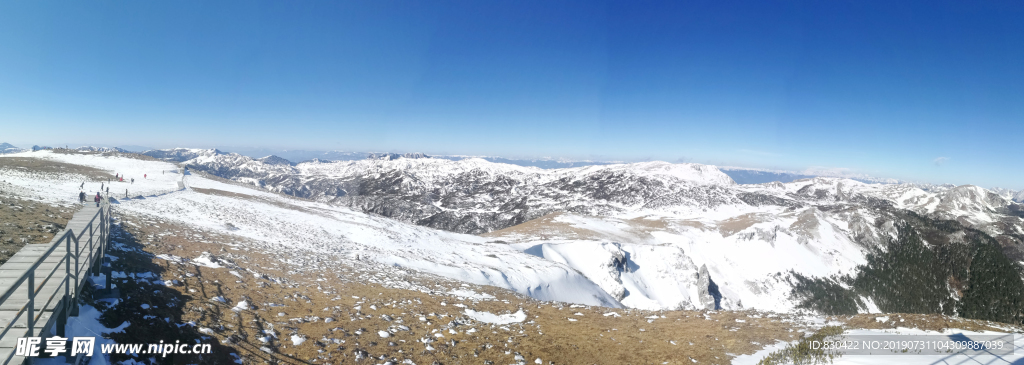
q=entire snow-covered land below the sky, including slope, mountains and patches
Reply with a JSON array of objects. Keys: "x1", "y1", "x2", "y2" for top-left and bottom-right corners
[{"x1": 0, "y1": 149, "x2": 1024, "y2": 362}]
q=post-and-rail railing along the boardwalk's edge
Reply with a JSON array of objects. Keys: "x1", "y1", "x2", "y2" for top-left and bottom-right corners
[{"x1": 0, "y1": 199, "x2": 111, "y2": 364}]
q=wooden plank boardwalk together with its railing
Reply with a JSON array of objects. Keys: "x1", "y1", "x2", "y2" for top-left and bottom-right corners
[{"x1": 0, "y1": 200, "x2": 111, "y2": 364}]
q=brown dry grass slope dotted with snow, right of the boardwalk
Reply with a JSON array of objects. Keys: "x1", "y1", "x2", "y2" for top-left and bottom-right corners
[{"x1": 114, "y1": 214, "x2": 815, "y2": 364}]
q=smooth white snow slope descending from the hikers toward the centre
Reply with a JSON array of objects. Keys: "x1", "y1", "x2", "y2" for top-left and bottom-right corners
[{"x1": 4, "y1": 152, "x2": 621, "y2": 308}]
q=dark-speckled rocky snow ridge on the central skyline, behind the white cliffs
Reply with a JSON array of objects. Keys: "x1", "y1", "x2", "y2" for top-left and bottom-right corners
[{"x1": 172, "y1": 150, "x2": 734, "y2": 234}]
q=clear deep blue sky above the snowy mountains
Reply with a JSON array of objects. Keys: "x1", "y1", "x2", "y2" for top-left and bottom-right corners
[{"x1": 0, "y1": 0, "x2": 1024, "y2": 189}]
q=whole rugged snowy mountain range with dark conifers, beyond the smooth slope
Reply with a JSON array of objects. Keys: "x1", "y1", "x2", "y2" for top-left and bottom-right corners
[{"x1": 130, "y1": 150, "x2": 1024, "y2": 314}]
